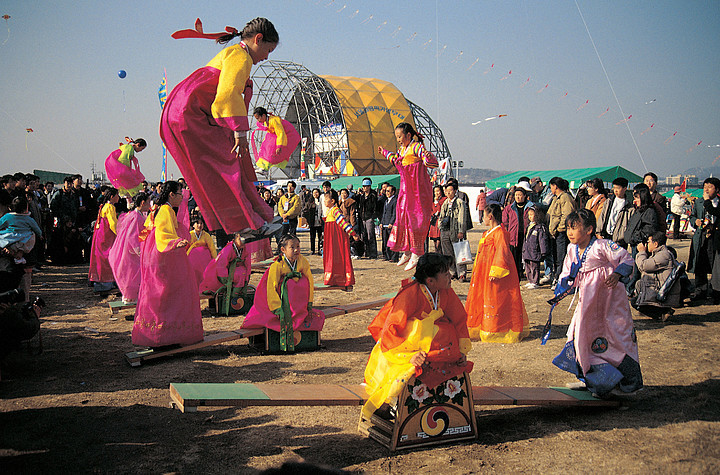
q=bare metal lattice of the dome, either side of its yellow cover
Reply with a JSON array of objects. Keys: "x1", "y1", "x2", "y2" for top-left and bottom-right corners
[{"x1": 250, "y1": 60, "x2": 453, "y2": 179}]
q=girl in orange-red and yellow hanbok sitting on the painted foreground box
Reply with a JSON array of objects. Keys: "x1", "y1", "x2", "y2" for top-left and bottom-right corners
[{"x1": 362, "y1": 253, "x2": 473, "y2": 419}]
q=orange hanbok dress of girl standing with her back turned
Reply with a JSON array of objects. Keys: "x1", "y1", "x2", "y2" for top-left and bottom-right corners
[{"x1": 465, "y1": 225, "x2": 530, "y2": 343}]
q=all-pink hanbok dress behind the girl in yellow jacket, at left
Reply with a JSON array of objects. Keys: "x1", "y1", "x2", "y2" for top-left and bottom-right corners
[{"x1": 108, "y1": 210, "x2": 146, "y2": 301}]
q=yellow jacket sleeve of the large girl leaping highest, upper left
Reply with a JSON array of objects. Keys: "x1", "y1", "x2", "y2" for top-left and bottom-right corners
[{"x1": 208, "y1": 46, "x2": 252, "y2": 130}]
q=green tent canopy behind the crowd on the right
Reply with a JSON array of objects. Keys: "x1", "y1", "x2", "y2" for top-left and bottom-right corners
[{"x1": 485, "y1": 166, "x2": 642, "y2": 190}]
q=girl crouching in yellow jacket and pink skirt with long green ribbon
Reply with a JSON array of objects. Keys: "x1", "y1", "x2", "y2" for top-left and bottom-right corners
[{"x1": 243, "y1": 234, "x2": 325, "y2": 351}]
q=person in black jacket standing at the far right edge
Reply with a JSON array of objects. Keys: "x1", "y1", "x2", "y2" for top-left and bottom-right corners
[{"x1": 687, "y1": 177, "x2": 720, "y2": 305}]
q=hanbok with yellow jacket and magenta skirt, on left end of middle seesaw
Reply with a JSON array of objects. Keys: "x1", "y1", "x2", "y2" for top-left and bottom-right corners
[{"x1": 132, "y1": 204, "x2": 203, "y2": 347}]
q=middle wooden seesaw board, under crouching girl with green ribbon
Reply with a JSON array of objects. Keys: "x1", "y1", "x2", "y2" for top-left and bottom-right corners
[{"x1": 125, "y1": 292, "x2": 396, "y2": 367}]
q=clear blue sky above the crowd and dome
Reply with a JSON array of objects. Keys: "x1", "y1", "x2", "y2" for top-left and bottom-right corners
[{"x1": 0, "y1": 0, "x2": 720, "y2": 180}]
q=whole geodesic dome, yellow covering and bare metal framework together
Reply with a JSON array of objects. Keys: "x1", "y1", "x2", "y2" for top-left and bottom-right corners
[{"x1": 252, "y1": 61, "x2": 452, "y2": 178}]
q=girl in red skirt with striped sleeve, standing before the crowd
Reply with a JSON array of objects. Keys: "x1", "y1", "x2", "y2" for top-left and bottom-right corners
[{"x1": 323, "y1": 190, "x2": 360, "y2": 287}]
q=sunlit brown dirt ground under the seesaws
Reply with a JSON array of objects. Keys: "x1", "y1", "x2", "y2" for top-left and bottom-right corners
[{"x1": 0, "y1": 229, "x2": 720, "y2": 473}]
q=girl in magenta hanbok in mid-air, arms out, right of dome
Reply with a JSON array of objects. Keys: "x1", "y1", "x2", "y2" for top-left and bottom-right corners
[{"x1": 378, "y1": 122, "x2": 438, "y2": 270}]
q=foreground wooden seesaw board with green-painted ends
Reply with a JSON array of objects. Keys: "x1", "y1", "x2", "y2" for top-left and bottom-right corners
[{"x1": 170, "y1": 383, "x2": 620, "y2": 412}]
